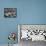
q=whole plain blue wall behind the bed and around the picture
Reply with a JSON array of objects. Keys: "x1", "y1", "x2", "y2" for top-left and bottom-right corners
[{"x1": 0, "y1": 0, "x2": 46, "y2": 44}]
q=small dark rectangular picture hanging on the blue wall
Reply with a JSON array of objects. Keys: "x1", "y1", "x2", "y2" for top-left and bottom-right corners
[{"x1": 4, "y1": 8, "x2": 17, "y2": 18}]
